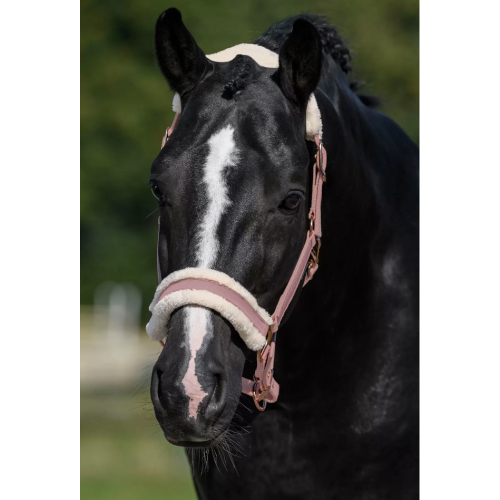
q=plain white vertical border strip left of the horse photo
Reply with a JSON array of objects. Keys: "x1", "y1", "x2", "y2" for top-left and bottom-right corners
[{"x1": 0, "y1": 1, "x2": 80, "y2": 500}]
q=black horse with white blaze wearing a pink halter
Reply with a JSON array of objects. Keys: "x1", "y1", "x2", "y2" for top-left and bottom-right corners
[{"x1": 150, "y1": 9, "x2": 419, "y2": 500}]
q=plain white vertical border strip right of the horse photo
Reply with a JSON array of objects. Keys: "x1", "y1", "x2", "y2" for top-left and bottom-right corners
[{"x1": 420, "y1": 0, "x2": 500, "y2": 500}]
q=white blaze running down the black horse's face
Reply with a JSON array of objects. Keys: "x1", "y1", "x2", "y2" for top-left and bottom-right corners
[{"x1": 182, "y1": 126, "x2": 238, "y2": 417}]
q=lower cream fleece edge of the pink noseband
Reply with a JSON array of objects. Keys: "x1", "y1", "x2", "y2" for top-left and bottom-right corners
[{"x1": 146, "y1": 290, "x2": 266, "y2": 351}]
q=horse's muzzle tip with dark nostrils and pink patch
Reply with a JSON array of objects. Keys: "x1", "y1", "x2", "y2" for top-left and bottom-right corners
[{"x1": 151, "y1": 363, "x2": 227, "y2": 444}]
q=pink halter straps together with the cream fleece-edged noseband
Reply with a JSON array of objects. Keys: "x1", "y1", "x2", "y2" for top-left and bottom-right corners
[{"x1": 146, "y1": 113, "x2": 326, "y2": 411}]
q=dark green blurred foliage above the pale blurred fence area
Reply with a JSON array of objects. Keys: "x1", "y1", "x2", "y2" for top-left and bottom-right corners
[{"x1": 81, "y1": 0, "x2": 419, "y2": 318}]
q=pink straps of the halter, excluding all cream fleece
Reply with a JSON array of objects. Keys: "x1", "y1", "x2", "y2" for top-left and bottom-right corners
[{"x1": 153, "y1": 113, "x2": 326, "y2": 411}]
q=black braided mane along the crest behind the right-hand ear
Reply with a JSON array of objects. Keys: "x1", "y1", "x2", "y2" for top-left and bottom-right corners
[{"x1": 254, "y1": 14, "x2": 380, "y2": 107}]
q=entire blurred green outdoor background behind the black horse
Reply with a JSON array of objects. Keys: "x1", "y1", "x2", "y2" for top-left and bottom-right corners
[{"x1": 81, "y1": 0, "x2": 419, "y2": 500}]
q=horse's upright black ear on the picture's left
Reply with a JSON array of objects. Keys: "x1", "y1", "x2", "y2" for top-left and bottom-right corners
[{"x1": 155, "y1": 8, "x2": 210, "y2": 95}]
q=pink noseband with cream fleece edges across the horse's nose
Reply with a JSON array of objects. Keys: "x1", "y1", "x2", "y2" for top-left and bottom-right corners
[{"x1": 146, "y1": 268, "x2": 273, "y2": 351}]
